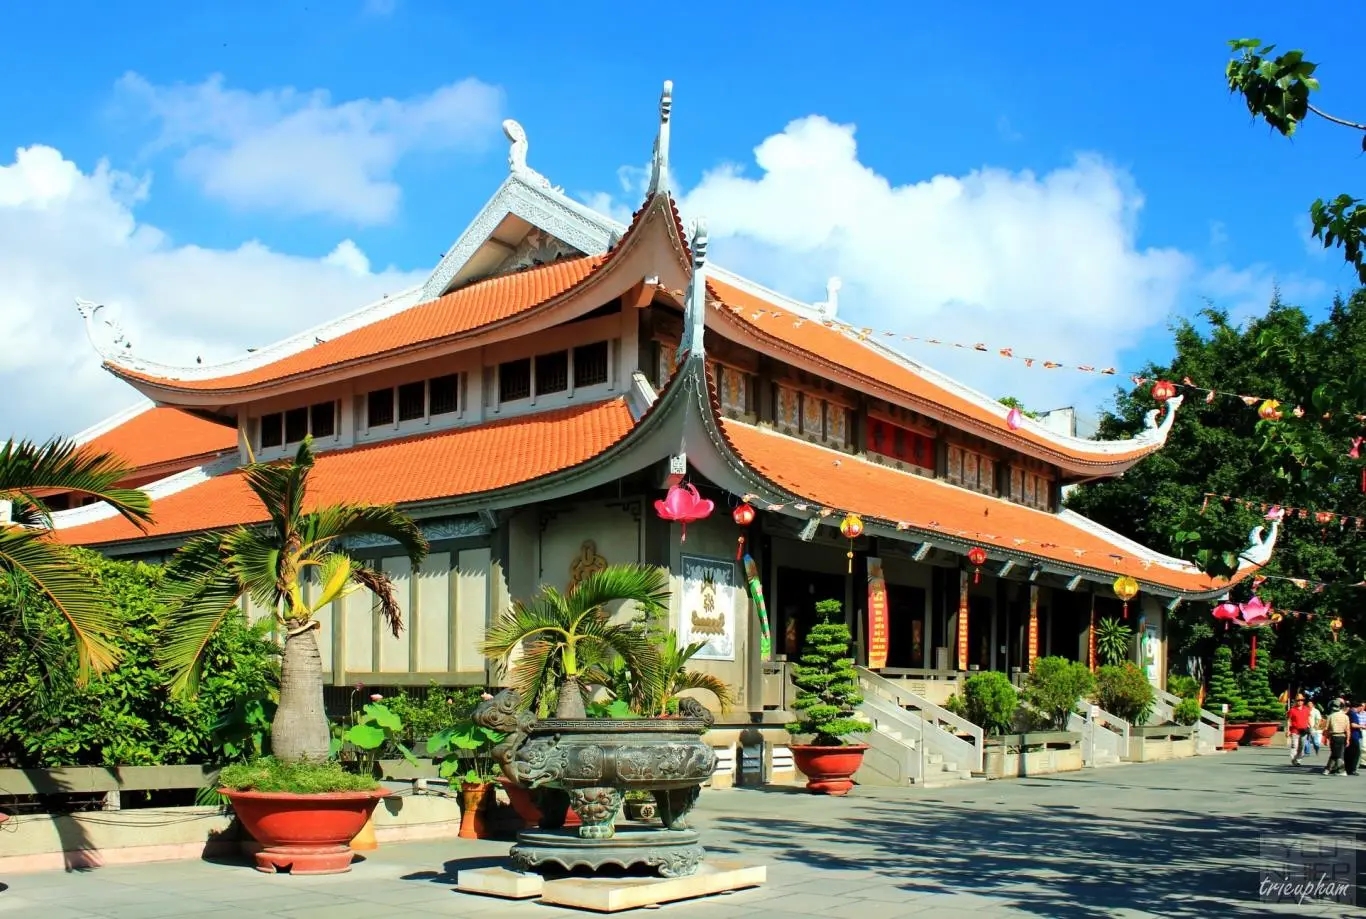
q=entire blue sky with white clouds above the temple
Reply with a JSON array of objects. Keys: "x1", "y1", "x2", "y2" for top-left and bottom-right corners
[{"x1": 0, "y1": 0, "x2": 1366, "y2": 436}]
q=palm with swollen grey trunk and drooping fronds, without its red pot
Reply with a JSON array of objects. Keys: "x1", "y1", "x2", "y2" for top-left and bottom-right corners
[{"x1": 153, "y1": 438, "x2": 428, "y2": 763}]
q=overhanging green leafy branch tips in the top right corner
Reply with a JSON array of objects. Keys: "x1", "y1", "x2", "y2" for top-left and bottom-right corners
[{"x1": 1224, "y1": 38, "x2": 1366, "y2": 284}]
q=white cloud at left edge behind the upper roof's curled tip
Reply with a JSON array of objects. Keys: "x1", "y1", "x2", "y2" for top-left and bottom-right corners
[{"x1": 0, "y1": 146, "x2": 422, "y2": 438}]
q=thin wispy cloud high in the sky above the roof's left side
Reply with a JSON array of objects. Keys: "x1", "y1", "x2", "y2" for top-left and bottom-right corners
[{"x1": 116, "y1": 74, "x2": 503, "y2": 224}]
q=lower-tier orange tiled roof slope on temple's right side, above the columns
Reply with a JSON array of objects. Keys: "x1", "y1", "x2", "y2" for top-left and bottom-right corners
[{"x1": 721, "y1": 419, "x2": 1227, "y2": 593}]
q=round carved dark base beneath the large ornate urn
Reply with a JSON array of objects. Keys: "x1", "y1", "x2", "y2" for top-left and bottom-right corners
[{"x1": 511, "y1": 826, "x2": 705, "y2": 878}]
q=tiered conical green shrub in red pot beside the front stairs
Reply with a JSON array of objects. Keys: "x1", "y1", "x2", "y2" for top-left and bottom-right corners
[{"x1": 787, "y1": 599, "x2": 869, "y2": 795}]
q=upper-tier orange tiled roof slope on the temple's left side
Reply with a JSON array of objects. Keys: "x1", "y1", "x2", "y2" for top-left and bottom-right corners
[{"x1": 111, "y1": 255, "x2": 607, "y2": 391}]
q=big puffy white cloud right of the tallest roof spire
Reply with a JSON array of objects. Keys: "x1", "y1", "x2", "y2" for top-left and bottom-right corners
[{"x1": 628, "y1": 116, "x2": 1197, "y2": 407}]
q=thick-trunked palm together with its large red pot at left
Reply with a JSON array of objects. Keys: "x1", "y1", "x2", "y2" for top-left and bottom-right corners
[{"x1": 161, "y1": 440, "x2": 428, "y2": 874}]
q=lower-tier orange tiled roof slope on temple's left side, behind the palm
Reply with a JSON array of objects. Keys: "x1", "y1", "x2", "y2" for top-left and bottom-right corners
[{"x1": 56, "y1": 399, "x2": 635, "y2": 545}]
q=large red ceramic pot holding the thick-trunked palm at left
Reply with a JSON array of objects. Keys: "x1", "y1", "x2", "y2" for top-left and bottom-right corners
[{"x1": 219, "y1": 788, "x2": 389, "y2": 874}]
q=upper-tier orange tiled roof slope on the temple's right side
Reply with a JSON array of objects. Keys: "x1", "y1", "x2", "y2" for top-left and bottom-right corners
[{"x1": 708, "y1": 279, "x2": 1153, "y2": 466}]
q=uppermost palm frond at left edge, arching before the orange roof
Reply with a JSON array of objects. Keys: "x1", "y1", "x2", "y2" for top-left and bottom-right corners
[{"x1": 0, "y1": 440, "x2": 152, "y2": 528}]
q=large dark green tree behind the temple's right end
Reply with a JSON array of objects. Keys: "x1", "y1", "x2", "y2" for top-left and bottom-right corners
[{"x1": 1068, "y1": 291, "x2": 1366, "y2": 688}]
